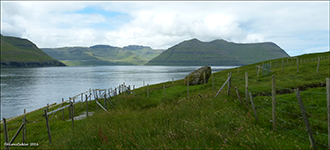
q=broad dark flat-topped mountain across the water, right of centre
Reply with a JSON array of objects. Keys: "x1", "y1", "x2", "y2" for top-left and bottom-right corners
[{"x1": 146, "y1": 39, "x2": 289, "y2": 66}]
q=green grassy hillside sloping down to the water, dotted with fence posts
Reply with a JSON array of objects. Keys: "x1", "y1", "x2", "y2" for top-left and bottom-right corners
[{"x1": 1, "y1": 52, "x2": 330, "y2": 149}]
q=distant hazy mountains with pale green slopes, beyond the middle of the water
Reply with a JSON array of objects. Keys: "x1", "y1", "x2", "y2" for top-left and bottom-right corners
[{"x1": 42, "y1": 45, "x2": 163, "y2": 66}]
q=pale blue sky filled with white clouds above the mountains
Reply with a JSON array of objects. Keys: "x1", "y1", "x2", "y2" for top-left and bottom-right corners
[{"x1": 1, "y1": 1, "x2": 330, "y2": 56}]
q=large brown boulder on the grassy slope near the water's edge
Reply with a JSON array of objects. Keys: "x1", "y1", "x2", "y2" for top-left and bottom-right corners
[{"x1": 184, "y1": 66, "x2": 212, "y2": 85}]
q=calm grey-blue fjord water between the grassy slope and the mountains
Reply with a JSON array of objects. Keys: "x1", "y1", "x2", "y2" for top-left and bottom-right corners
[{"x1": 1, "y1": 66, "x2": 233, "y2": 118}]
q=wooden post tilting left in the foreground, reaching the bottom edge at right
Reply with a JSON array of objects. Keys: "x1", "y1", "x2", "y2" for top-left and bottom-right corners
[{"x1": 295, "y1": 89, "x2": 316, "y2": 149}]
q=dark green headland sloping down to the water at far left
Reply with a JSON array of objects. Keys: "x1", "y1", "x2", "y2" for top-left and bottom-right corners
[{"x1": 1, "y1": 35, "x2": 65, "y2": 67}]
